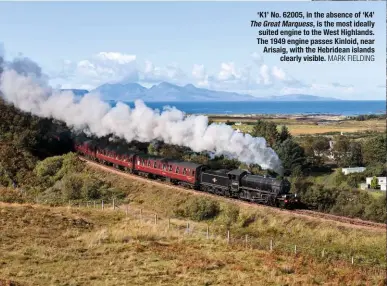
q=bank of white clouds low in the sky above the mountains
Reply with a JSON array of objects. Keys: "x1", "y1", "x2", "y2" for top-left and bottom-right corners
[{"x1": 50, "y1": 49, "x2": 355, "y2": 96}]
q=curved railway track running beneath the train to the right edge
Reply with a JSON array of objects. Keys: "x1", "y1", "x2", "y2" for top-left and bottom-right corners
[{"x1": 78, "y1": 156, "x2": 386, "y2": 231}]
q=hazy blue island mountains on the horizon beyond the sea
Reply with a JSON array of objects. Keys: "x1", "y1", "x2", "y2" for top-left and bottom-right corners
[{"x1": 59, "y1": 82, "x2": 338, "y2": 102}]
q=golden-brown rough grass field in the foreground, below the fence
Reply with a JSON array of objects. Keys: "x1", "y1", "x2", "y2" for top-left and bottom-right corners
[{"x1": 0, "y1": 204, "x2": 384, "y2": 285}]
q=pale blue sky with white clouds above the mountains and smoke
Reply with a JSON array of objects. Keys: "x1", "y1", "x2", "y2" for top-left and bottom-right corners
[{"x1": 0, "y1": 1, "x2": 386, "y2": 100}]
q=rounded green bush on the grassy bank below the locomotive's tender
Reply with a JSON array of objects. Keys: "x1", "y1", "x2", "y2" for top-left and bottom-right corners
[{"x1": 174, "y1": 197, "x2": 220, "y2": 221}]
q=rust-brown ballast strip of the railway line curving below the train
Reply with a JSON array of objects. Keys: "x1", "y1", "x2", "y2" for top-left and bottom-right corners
[{"x1": 80, "y1": 157, "x2": 386, "y2": 232}]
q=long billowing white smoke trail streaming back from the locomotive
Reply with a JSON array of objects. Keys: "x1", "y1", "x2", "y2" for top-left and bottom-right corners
[{"x1": 0, "y1": 56, "x2": 282, "y2": 174}]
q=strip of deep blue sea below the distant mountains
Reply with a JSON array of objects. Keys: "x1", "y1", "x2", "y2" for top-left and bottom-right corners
[{"x1": 113, "y1": 100, "x2": 386, "y2": 116}]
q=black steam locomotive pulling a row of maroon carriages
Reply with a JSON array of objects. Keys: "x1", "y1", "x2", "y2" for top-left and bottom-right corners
[{"x1": 74, "y1": 137, "x2": 299, "y2": 208}]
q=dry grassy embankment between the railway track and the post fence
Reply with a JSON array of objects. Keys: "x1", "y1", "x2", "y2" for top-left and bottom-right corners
[{"x1": 85, "y1": 168, "x2": 386, "y2": 267}]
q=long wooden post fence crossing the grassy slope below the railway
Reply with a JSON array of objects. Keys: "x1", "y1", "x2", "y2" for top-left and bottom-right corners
[{"x1": 69, "y1": 199, "x2": 386, "y2": 275}]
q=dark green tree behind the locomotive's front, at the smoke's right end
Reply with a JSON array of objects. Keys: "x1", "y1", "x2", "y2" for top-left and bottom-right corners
[{"x1": 274, "y1": 139, "x2": 306, "y2": 175}]
